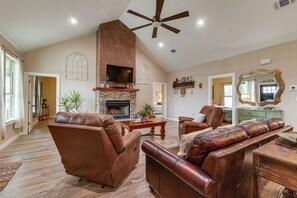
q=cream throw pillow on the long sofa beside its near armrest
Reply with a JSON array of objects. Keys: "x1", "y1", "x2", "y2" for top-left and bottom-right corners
[{"x1": 177, "y1": 127, "x2": 212, "y2": 158}]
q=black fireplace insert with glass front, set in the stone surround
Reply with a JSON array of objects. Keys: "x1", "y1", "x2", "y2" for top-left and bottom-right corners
[{"x1": 106, "y1": 100, "x2": 130, "y2": 119}]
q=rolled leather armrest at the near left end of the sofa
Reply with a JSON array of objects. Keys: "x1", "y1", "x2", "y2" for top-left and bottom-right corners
[{"x1": 142, "y1": 140, "x2": 218, "y2": 197}]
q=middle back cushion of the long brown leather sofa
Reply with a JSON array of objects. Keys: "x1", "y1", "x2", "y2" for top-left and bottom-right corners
[{"x1": 236, "y1": 121, "x2": 269, "y2": 137}]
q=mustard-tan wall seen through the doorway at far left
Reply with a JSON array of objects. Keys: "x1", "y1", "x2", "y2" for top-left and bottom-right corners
[{"x1": 41, "y1": 77, "x2": 56, "y2": 117}]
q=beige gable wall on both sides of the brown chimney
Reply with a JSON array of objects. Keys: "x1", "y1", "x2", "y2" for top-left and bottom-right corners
[{"x1": 24, "y1": 33, "x2": 166, "y2": 112}]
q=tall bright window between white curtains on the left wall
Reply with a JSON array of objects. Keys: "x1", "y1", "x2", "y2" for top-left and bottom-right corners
[{"x1": 5, "y1": 54, "x2": 16, "y2": 120}]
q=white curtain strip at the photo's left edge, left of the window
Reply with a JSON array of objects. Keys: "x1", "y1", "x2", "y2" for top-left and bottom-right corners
[{"x1": 0, "y1": 48, "x2": 6, "y2": 140}]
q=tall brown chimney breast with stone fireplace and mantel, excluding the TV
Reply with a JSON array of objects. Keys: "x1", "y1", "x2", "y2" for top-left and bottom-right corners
[{"x1": 93, "y1": 20, "x2": 139, "y2": 119}]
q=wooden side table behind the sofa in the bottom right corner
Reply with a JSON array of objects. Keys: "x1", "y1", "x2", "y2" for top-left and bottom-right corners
[{"x1": 253, "y1": 138, "x2": 297, "y2": 197}]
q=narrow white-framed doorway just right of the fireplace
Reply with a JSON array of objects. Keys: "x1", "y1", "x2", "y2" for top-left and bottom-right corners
[{"x1": 153, "y1": 82, "x2": 167, "y2": 118}]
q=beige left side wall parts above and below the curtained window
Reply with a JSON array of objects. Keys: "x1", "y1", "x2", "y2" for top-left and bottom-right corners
[{"x1": 0, "y1": 34, "x2": 22, "y2": 145}]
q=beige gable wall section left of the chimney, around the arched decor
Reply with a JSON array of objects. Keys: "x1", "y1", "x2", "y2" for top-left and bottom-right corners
[{"x1": 24, "y1": 33, "x2": 96, "y2": 112}]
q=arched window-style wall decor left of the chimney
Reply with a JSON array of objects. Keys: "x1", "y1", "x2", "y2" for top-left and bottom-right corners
[{"x1": 65, "y1": 52, "x2": 88, "y2": 80}]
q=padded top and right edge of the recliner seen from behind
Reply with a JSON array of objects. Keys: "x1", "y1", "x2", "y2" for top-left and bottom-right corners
[{"x1": 55, "y1": 112, "x2": 124, "y2": 153}]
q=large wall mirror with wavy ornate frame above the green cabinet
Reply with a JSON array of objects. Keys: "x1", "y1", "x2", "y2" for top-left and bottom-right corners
[{"x1": 237, "y1": 69, "x2": 285, "y2": 106}]
